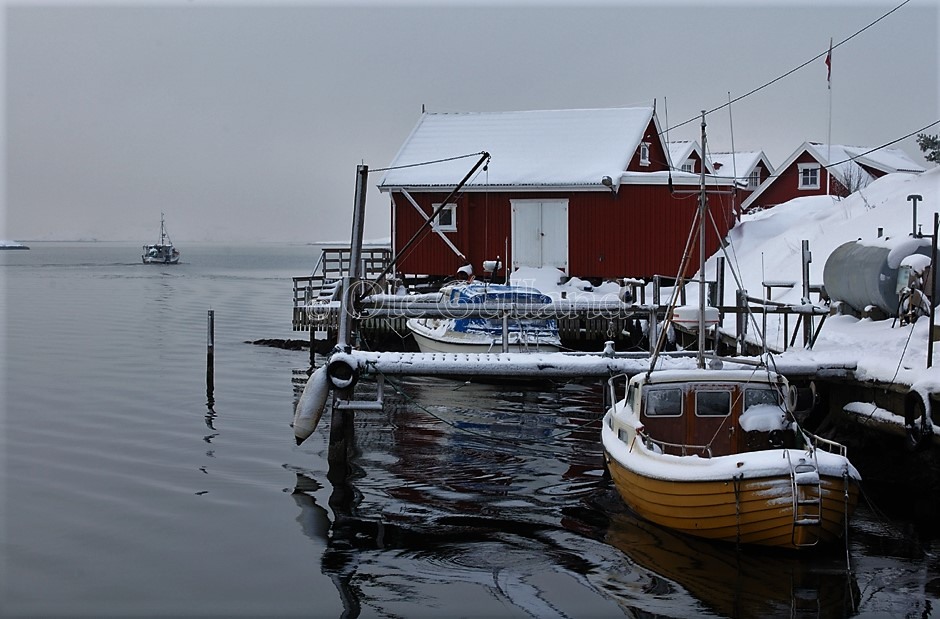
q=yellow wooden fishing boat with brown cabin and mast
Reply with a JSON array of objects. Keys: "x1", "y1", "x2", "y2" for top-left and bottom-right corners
[{"x1": 601, "y1": 114, "x2": 861, "y2": 549}]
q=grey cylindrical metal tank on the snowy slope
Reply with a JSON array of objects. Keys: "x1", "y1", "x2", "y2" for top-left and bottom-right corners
[{"x1": 823, "y1": 236, "x2": 936, "y2": 316}]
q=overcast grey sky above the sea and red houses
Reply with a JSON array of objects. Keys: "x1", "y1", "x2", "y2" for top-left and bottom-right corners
[{"x1": 0, "y1": 0, "x2": 940, "y2": 245}]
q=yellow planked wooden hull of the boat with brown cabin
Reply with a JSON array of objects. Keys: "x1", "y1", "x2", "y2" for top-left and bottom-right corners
[{"x1": 606, "y1": 453, "x2": 858, "y2": 548}]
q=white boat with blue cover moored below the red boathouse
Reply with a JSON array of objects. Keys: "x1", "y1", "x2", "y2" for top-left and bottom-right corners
[{"x1": 406, "y1": 282, "x2": 561, "y2": 353}]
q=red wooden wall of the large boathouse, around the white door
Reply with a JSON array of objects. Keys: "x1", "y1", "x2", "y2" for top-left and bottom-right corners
[{"x1": 392, "y1": 182, "x2": 733, "y2": 279}]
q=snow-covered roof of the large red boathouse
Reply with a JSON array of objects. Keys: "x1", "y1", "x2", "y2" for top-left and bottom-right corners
[{"x1": 378, "y1": 107, "x2": 659, "y2": 191}]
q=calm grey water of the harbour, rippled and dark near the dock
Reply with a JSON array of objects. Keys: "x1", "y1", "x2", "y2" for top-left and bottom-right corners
[{"x1": 0, "y1": 243, "x2": 940, "y2": 618}]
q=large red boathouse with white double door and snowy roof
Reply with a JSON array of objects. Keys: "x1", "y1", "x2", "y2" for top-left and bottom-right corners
[{"x1": 378, "y1": 107, "x2": 734, "y2": 280}]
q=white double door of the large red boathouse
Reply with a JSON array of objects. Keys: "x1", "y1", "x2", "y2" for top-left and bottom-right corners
[{"x1": 511, "y1": 200, "x2": 568, "y2": 273}]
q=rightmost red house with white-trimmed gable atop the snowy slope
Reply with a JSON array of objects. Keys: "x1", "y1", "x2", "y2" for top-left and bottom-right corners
[{"x1": 742, "y1": 142, "x2": 924, "y2": 211}]
